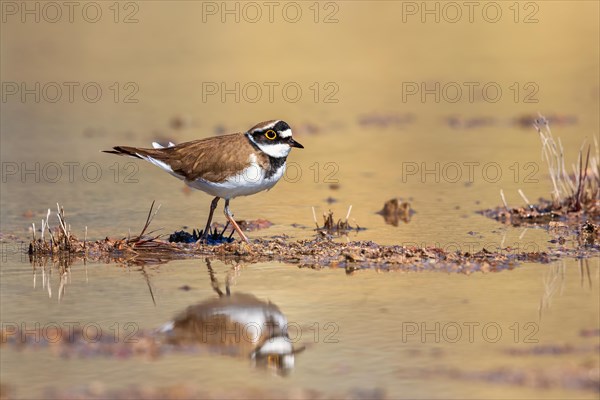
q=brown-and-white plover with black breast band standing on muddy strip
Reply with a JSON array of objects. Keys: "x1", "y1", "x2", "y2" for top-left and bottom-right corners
[{"x1": 105, "y1": 120, "x2": 304, "y2": 242}]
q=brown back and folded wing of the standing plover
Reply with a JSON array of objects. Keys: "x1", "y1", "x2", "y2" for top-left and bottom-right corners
[{"x1": 107, "y1": 133, "x2": 253, "y2": 182}]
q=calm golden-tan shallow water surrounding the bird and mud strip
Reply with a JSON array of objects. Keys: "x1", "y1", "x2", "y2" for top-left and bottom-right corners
[{"x1": 0, "y1": 2, "x2": 600, "y2": 398}]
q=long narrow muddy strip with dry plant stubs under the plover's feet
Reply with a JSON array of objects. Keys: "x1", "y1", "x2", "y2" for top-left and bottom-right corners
[{"x1": 22, "y1": 203, "x2": 600, "y2": 274}]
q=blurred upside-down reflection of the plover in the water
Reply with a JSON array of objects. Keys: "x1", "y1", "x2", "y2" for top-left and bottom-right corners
[{"x1": 161, "y1": 259, "x2": 304, "y2": 375}]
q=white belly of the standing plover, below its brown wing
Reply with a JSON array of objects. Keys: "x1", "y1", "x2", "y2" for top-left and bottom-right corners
[{"x1": 185, "y1": 163, "x2": 285, "y2": 199}]
